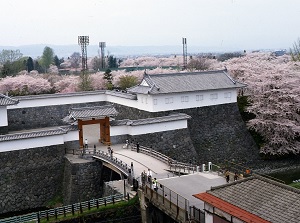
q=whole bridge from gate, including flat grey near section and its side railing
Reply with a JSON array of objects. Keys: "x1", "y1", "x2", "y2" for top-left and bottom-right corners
[{"x1": 84, "y1": 144, "x2": 226, "y2": 222}]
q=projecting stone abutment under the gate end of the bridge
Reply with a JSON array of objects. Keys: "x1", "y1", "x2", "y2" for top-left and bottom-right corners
[{"x1": 63, "y1": 156, "x2": 102, "y2": 205}]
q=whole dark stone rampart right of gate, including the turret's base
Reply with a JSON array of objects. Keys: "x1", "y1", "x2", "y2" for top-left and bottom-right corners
[{"x1": 115, "y1": 103, "x2": 261, "y2": 165}]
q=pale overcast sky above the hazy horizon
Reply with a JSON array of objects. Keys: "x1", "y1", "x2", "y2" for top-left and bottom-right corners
[{"x1": 0, "y1": 0, "x2": 300, "y2": 49}]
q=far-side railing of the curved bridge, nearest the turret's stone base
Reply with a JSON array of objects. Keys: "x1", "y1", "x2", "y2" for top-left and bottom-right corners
[{"x1": 130, "y1": 145, "x2": 200, "y2": 173}]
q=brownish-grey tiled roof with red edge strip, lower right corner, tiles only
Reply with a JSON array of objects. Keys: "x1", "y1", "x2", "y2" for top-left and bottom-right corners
[{"x1": 195, "y1": 175, "x2": 300, "y2": 223}]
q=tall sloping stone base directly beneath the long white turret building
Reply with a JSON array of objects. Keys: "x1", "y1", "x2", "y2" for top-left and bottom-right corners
[{"x1": 181, "y1": 103, "x2": 260, "y2": 165}]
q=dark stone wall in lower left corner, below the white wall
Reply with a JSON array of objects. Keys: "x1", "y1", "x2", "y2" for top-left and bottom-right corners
[{"x1": 0, "y1": 145, "x2": 65, "y2": 213}]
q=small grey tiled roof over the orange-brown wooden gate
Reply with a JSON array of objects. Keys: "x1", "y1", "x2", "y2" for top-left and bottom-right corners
[{"x1": 64, "y1": 105, "x2": 118, "y2": 121}]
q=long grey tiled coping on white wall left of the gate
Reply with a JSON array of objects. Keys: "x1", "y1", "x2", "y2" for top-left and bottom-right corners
[{"x1": 0, "y1": 127, "x2": 67, "y2": 142}]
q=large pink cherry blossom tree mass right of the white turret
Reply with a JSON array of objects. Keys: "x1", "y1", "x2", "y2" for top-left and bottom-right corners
[{"x1": 223, "y1": 53, "x2": 300, "y2": 155}]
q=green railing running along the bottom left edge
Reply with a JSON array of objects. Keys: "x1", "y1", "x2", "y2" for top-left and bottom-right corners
[{"x1": 0, "y1": 194, "x2": 124, "y2": 223}]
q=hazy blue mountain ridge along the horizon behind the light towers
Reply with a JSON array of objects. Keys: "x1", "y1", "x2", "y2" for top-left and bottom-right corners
[{"x1": 0, "y1": 44, "x2": 282, "y2": 59}]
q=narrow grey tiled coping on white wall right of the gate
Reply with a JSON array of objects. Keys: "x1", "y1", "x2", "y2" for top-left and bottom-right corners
[{"x1": 110, "y1": 113, "x2": 191, "y2": 126}]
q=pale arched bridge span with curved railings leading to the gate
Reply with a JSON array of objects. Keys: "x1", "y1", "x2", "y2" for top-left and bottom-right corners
[{"x1": 84, "y1": 144, "x2": 200, "y2": 182}]
